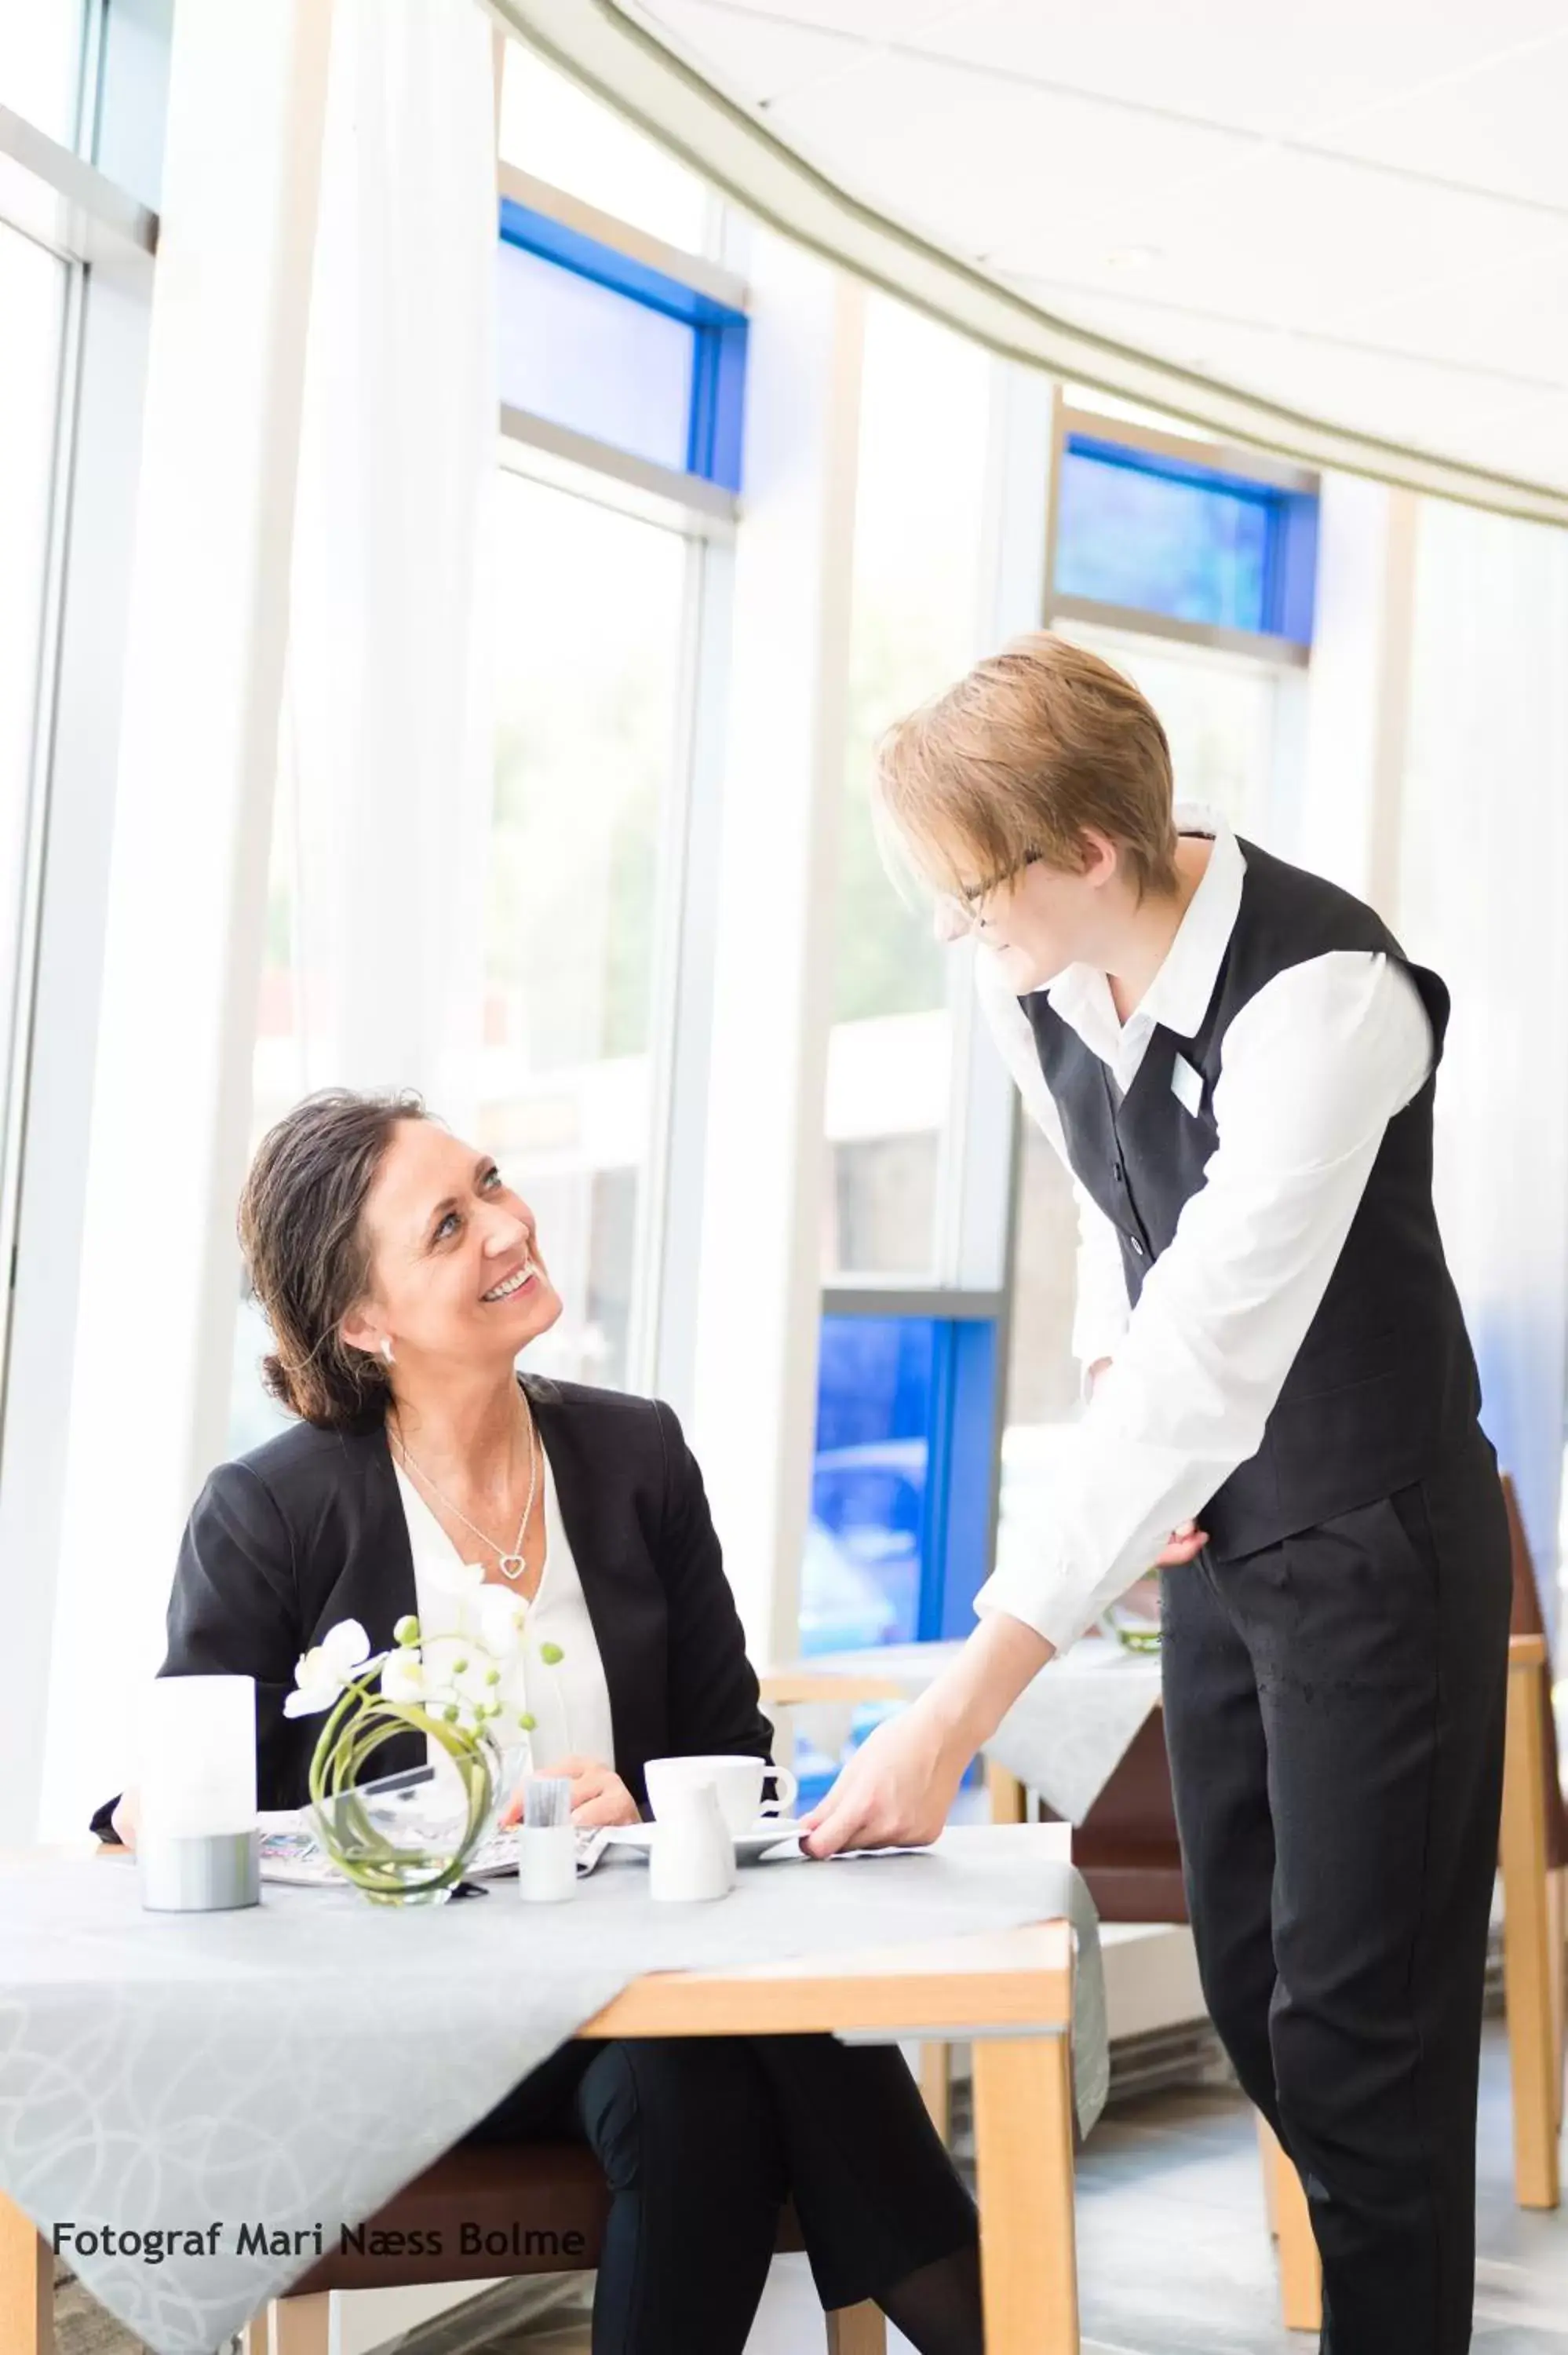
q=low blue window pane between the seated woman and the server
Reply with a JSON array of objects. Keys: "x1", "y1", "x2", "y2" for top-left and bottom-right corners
[{"x1": 800, "y1": 1316, "x2": 946, "y2": 1653}]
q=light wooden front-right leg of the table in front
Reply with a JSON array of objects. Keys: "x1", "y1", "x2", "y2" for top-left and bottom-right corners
[{"x1": 972, "y1": 2035, "x2": 1078, "y2": 2355}]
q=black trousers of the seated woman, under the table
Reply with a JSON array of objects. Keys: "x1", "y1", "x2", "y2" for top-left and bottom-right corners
[{"x1": 469, "y1": 2037, "x2": 977, "y2": 2355}]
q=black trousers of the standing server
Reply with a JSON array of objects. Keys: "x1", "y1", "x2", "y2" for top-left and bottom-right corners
[{"x1": 1161, "y1": 1429, "x2": 1509, "y2": 2355}]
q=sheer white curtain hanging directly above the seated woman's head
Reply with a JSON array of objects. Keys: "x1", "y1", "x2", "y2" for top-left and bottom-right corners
[{"x1": 280, "y1": 0, "x2": 497, "y2": 1130}]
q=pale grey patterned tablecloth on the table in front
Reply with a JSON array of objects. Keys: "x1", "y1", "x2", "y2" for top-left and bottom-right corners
[{"x1": 0, "y1": 1827, "x2": 1107, "y2": 2355}]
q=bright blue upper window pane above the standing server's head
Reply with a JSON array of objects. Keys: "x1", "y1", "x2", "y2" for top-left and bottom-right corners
[{"x1": 1055, "y1": 440, "x2": 1278, "y2": 629}]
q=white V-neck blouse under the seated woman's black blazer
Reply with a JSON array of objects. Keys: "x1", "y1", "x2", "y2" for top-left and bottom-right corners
[{"x1": 393, "y1": 1448, "x2": 614, "y2": 1771}]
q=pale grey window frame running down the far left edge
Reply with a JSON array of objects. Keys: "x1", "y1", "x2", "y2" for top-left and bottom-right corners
[{"x1": 0, "y1": 0, "x2": 170, "y2": 1839}]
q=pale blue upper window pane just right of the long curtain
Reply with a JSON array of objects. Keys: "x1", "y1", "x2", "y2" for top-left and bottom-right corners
[{"x1": 497, "y1": 243, "x2": 697, "y2": 471}]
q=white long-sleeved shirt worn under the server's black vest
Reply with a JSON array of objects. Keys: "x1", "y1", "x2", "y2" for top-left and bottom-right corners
[{"x1": 975, "y1": 805, "x2": 1431, "y2": 1651}]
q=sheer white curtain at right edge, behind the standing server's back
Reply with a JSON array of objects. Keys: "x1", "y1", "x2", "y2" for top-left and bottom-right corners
[{"x1": 1398, "y1": 499, "x2": 1568, "y2": 1623}]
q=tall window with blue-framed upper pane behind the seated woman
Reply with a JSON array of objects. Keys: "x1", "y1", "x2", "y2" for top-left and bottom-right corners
[{"x1": 231, "y1": 42, "x2": 746, "y2": 1451}]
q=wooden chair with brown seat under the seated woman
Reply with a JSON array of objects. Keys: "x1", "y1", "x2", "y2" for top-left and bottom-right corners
[{"x1": 242, "y1": 2143, "x2": 888, "y2": 2355}]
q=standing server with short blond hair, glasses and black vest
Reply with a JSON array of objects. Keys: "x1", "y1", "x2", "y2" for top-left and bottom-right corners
[{"x1": 808, "y1": 633, "x2": 1509, "y2": 2355}]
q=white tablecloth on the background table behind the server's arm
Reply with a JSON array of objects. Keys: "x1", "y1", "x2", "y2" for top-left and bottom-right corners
[{"x1": 796, "y1": 1634, "x2": 1161, "y2": 1823}]
